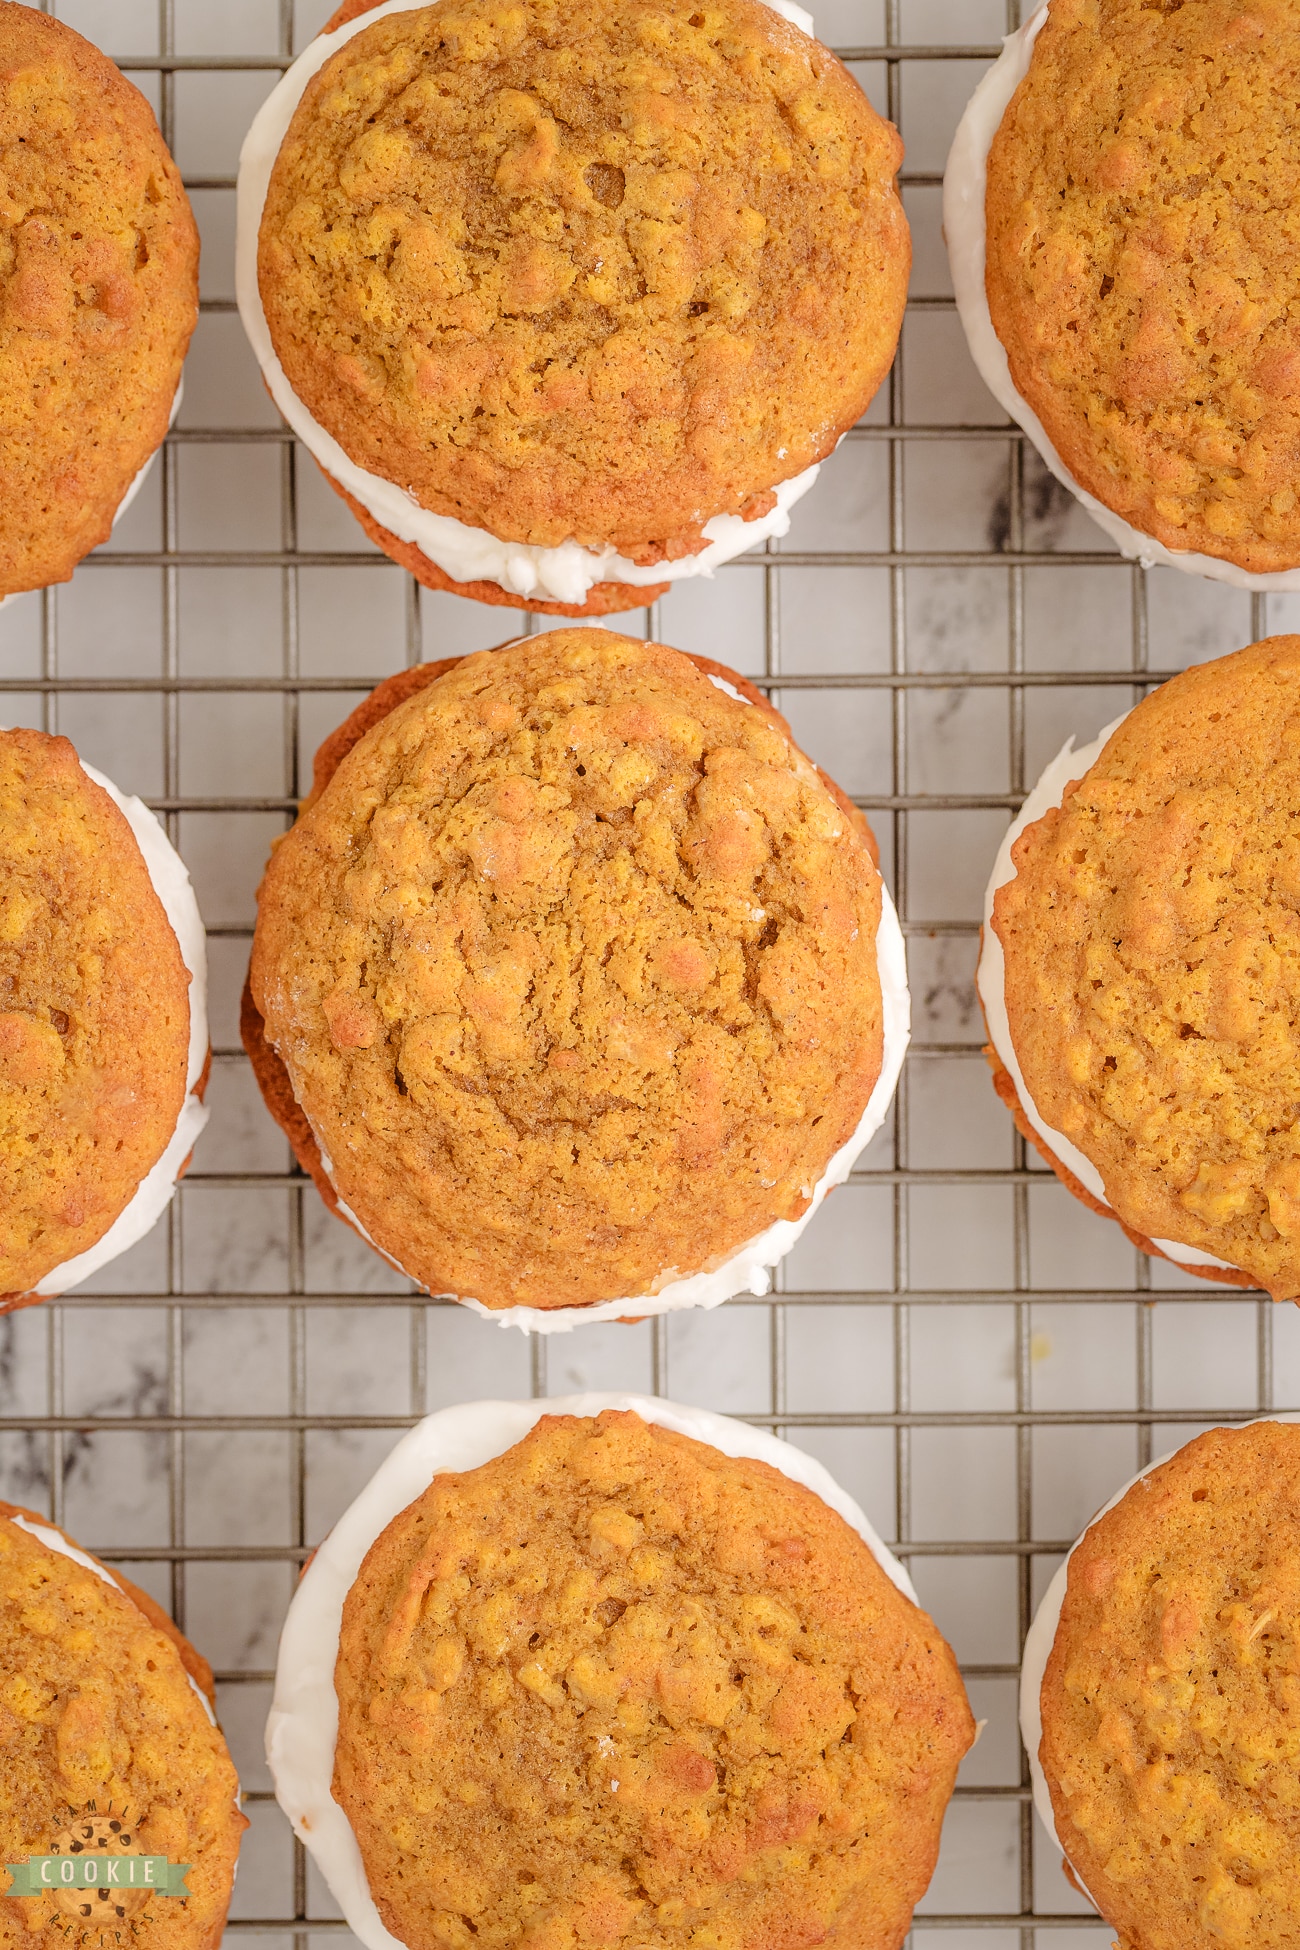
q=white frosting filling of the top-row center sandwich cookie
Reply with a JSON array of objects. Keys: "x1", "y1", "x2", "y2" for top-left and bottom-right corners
[{"x1": 236, "y1": 0, "x2": 817, "y2": 603}]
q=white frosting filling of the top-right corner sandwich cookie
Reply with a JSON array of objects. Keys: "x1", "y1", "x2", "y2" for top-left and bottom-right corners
[{"x1": 943, "y1": 0, "x2": 1300, "y2": 591}]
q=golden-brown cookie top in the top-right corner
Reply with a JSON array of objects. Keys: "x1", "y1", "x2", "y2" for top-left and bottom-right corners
[{"x1": 986, "y1": 0, "x2": 1300, "y2": 571}]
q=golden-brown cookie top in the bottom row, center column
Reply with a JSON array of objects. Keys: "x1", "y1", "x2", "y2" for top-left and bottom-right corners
[{"x1": 333, "y1": 1412, "x2": 975, "y2": 1950}]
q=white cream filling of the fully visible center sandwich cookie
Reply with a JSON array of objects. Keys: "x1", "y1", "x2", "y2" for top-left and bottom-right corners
[{"x1": 272, "y1": 666, "x2": 912, "y2": 1334}]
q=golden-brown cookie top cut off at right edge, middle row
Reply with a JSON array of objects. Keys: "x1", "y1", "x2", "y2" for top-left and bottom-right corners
[{"x1": 994, "y1": 636, "x2": 1300, "y2": 1299}]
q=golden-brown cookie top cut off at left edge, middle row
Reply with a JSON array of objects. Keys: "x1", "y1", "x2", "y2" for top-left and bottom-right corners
[{"x1": 0, "y1": 731, "x2": 189, "y2": 1295}]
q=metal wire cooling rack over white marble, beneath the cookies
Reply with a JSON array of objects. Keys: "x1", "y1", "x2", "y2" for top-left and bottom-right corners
[{"x1": 0, "y1": 0, "x2": 1300, "y2": 1950}]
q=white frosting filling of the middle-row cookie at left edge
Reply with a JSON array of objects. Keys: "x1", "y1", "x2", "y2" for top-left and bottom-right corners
[{"x1": 3, "y1": 759, "x2": 209, "y2": 1301}]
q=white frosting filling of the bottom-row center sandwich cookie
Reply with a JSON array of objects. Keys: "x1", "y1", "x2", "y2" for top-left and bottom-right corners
[{"x1": 267, "y1": 1394, "x2": 916, "y2": 1950}]
